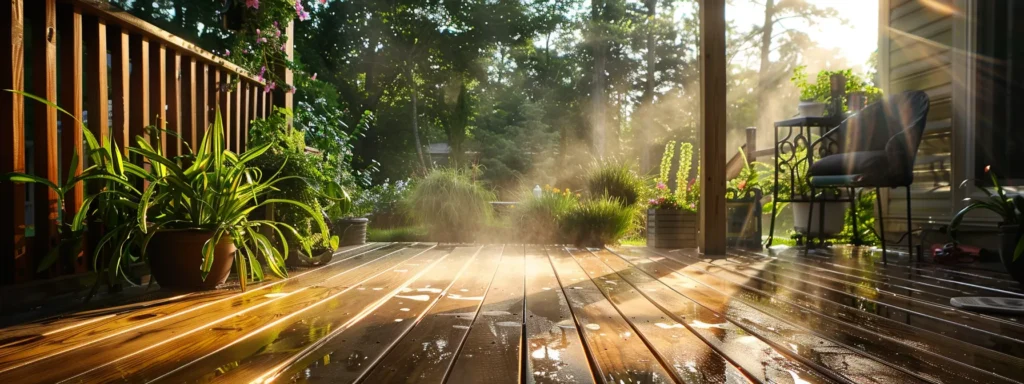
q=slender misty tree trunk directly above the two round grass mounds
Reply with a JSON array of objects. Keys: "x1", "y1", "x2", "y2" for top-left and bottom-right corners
[{"x1": 590, "y1": 0, "x2": 608, "y2": 159}]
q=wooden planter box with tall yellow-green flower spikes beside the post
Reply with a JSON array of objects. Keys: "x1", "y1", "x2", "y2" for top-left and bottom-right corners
[{"x1": 647, "y1": 141, "x2": 699, "y2": 248}]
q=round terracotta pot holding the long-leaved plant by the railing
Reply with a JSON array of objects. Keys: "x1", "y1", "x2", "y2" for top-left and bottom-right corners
[{"x1": 145, "y1": 229, "x2": 234, "y2": 291}]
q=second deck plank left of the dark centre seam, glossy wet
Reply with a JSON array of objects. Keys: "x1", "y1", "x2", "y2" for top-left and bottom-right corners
[{"x1": 364, "y1": 246, "x2": 502, "y2": 383}]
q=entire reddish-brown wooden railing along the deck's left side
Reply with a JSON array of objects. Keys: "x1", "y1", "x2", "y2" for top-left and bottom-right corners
[{"x1": 0, "y1": 0, "x2": 276, "y2": 284}]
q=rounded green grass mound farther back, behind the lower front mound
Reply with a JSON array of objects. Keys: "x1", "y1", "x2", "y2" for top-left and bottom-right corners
[{"x1": 583, "y1": 160, "x2": 646, "y2": 207}]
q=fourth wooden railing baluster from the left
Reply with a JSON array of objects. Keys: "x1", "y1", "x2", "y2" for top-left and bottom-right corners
[{"x1": 82, "y1": 17, "x2": 110, "y2": 141}]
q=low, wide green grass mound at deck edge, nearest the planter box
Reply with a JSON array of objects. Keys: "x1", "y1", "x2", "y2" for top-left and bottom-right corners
[{"x1": 560, "y1": 197, "x2": 635, "y2": 246}]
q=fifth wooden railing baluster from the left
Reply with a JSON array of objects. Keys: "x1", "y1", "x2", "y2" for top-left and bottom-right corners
[{"x1": 103, "y1": 27, "x2": 132, "y2": 151}]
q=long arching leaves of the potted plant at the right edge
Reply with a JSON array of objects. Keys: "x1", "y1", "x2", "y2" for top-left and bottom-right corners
[{"x1": 949, "y1": 166, "x2": 1024, "y2": 261}]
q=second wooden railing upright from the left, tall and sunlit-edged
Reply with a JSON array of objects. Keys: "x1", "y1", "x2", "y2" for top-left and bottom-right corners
[{"x1": 29, "y1": 0, "x2": 60, "y2": 274}]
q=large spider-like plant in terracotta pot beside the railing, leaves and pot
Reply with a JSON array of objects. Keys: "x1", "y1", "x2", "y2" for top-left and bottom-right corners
[{"x1": 129, "y1": 111, "x2": 330, "y2": 291}]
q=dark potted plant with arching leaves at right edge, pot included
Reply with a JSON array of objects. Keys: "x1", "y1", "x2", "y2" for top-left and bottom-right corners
[{"x1": 949, "y1": 166, "x2": 1024, "y2": 283}]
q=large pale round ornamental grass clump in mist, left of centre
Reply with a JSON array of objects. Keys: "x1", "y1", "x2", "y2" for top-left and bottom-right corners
[{"x1": 409, "y1": 168, "x2": 495, "y2": 242}]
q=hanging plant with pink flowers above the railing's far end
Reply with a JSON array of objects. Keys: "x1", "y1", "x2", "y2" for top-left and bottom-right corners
[{"x1": 221, "y1": 0, "x2": 327, "y2": 93}]
